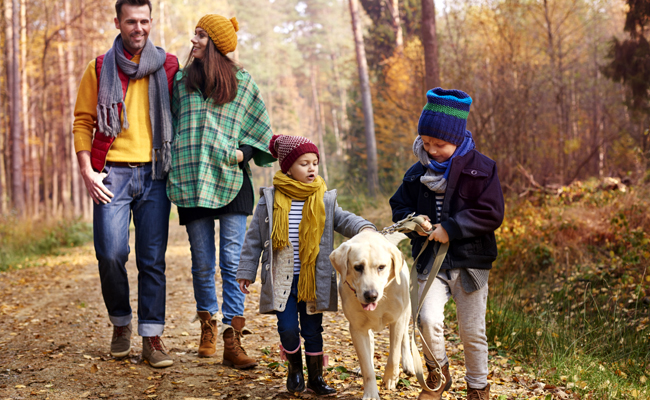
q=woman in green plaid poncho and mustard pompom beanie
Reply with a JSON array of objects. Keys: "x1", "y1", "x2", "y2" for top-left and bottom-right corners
[{"x1": 167, "y1": 14, "x2": 274, "y2": 369}]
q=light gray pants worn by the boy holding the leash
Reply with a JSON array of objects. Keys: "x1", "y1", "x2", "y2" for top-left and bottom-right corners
[{"x1": 418, "y1": 269, "x2": 488, "y2": 389}]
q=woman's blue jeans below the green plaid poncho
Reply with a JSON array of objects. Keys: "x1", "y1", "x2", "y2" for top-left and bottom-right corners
[{"x1": 185, "y1": 214, "x2": 246, "y2": 325}]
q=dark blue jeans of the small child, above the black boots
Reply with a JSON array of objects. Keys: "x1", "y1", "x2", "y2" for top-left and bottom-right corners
[{"x1": 276, "y1": 275, "x2": 323, "y2": 353}]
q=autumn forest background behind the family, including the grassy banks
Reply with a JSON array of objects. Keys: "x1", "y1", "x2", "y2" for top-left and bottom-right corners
[{"x1": 0, "y1": 0, "x2": 650, "y2": 398}]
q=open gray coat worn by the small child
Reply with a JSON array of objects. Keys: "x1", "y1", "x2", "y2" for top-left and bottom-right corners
[{"x1": 237, "y1": 187, "x2": 375, "y2": 314}]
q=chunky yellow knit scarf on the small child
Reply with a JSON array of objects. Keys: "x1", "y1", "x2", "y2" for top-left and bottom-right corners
[{"x1": 271, "y1": 171, "x2": 327, "y2": 301}]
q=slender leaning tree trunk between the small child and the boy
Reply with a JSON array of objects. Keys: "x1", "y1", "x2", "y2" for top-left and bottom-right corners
[{"x1": 349, "y1": 0, "x2": 379, "y2": 198}]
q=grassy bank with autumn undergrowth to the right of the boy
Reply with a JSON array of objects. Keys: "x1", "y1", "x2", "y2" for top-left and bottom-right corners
[{"x1": 487, "y1": 181, "x2": 650, "y2": 399}]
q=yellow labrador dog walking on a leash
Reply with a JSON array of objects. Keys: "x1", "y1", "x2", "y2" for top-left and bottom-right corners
[{"x1": 330, "y1": 230, "x2": 414, "y2": 400}]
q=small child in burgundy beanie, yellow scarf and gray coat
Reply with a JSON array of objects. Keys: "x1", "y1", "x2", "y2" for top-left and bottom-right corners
[{"x1": 237, "y1": 135, "x2": 376, "y2": 395}]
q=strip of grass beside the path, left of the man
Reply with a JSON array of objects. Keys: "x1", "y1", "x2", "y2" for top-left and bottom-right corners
[{"x1": 0, "y1": 218, "x2": 92, "y2": 271}]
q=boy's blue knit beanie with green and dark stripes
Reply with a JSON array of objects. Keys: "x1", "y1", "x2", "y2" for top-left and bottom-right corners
[{"x1": 418, "y1": 88, "x2": 472, "y2": 146}]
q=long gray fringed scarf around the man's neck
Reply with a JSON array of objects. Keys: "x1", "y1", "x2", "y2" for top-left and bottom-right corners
[{"x1": 97, "y1": 35, "x2": 173, "y2": 179}]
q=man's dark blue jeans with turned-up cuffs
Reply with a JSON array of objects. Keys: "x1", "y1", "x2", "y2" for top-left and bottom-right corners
[{"x1": 93, "y1": 165, "x2": 171, "y2": 336}]
